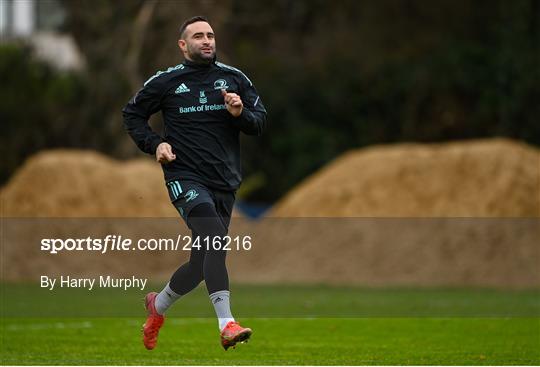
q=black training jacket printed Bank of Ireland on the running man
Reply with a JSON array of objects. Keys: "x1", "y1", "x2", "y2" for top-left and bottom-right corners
[{"x1": 122, "y1": 60, "x2": 266, "y2": 190}]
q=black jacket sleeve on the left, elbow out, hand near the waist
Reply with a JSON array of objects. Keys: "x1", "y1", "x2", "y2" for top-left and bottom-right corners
[{"x1": 122, "y1": 80, "x2": 165, "y2": 154}]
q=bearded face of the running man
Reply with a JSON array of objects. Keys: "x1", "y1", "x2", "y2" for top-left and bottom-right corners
[{"x1": 178, "y1": 22, "x2": 216, "y2": 63}]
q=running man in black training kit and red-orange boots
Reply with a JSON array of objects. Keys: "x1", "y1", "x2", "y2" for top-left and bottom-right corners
[{"x1": 122, "y1": 16, "x2": 266, "y2": 350}]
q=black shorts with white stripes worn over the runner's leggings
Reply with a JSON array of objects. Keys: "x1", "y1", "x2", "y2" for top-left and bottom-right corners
[{"x1": 167, "y1": 180, "x2": 236, "y2": 228}]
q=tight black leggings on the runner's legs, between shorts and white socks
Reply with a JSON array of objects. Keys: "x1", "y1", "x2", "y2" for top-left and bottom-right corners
[{"x1": 169, "y1": 203, "x2": 229, "y2": 295}]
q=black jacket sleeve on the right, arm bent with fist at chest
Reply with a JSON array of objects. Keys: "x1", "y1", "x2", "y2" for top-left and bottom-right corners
[{"x1": 233, "y1": 74, "x2": 266, "y2": 136}]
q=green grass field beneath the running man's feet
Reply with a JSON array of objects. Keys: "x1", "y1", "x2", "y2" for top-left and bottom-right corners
[{"x1": 1, "y1": 284, "x2": 540, "y2": 365}]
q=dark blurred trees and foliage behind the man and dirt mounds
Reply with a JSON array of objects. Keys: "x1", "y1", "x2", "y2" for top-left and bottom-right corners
[{"x1": 0, "y1": 0, "x2": 540, "y2": 203}]
